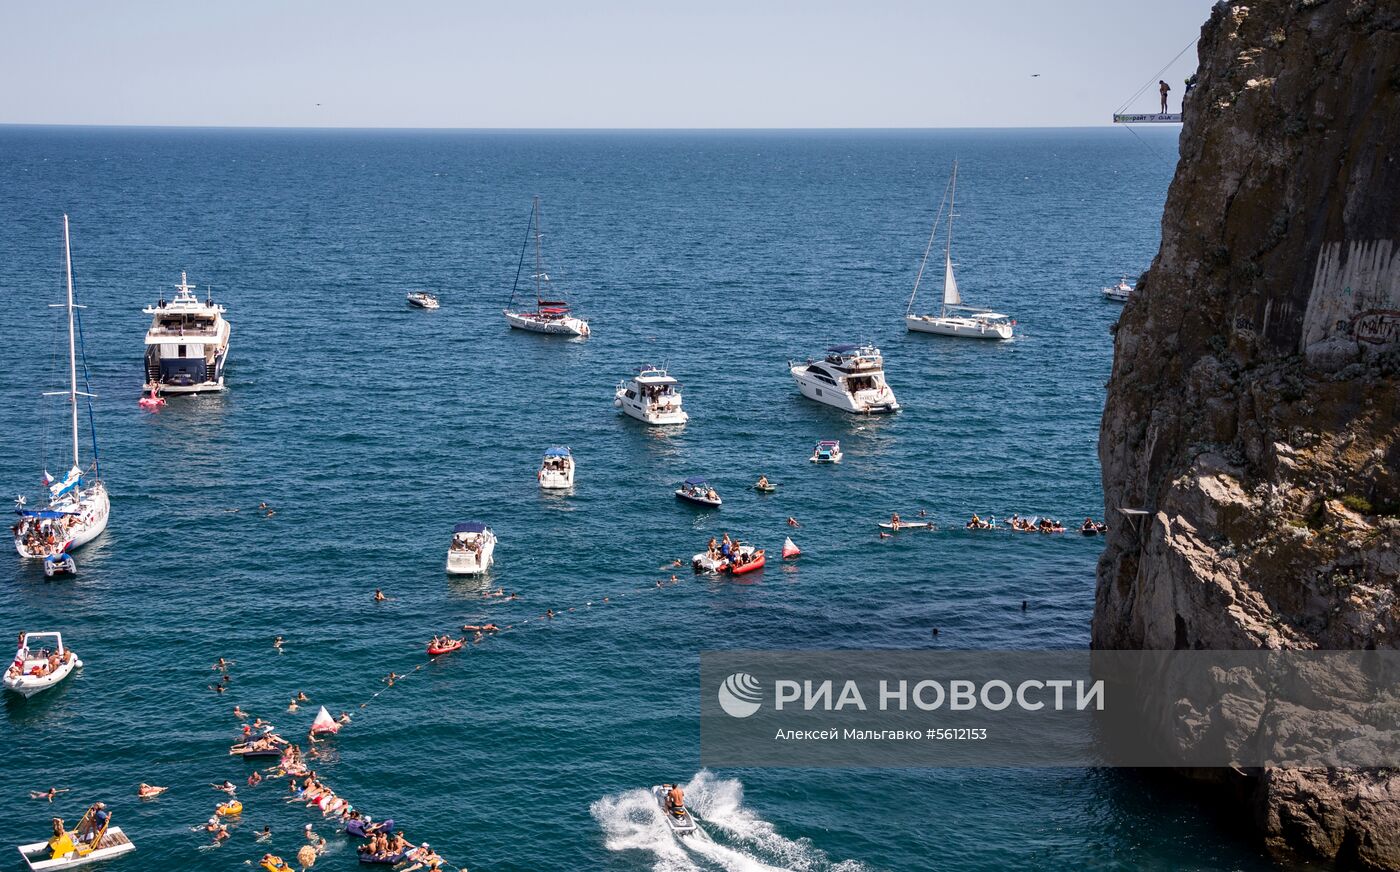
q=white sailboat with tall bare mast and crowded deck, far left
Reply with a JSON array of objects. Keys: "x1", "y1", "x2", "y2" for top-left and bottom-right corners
[{"x1": 14, "y1": 216, "x2": 111, "y2": 567}]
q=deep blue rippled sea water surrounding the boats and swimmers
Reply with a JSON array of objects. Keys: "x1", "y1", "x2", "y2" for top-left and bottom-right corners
[{"x1": 0, "y1": 127, "x2": 1266, "y2": 871}]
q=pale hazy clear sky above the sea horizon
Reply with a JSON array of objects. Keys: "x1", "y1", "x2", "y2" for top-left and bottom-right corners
[{"x1": 0, "y1": 0, "x2": 1211, "y2": 129}]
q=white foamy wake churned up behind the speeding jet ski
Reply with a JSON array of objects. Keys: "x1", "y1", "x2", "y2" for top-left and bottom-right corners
[{"x1": 589, "y1": 770, "x2": 865, "y2": 872}]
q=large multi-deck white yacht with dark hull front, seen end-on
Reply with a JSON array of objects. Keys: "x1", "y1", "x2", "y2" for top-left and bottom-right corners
[{"x1": 141, "y1": 273, "x2": 230, "y2": 393}]
